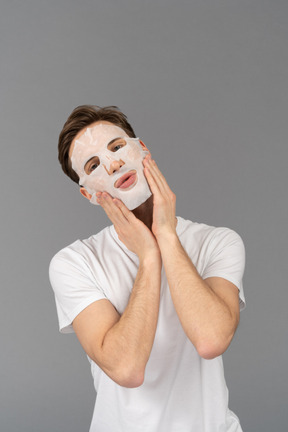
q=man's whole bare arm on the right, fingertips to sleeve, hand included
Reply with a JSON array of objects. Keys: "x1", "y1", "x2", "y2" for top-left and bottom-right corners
[{"x1": 144, "y1": 158, "x2": 239, "y2": 359}]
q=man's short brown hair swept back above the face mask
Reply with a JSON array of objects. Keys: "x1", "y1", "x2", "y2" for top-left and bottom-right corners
[{"x1": 58, "y1": 105, "x2": 136, "y2": 183}]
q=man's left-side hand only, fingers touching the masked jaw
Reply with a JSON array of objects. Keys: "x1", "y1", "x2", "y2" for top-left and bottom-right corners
[{"x1": 96, "y1": 192, "x2": 161, "y2": 261}]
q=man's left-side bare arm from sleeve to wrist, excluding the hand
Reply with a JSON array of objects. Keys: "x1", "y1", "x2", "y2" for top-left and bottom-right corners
[{"x1": 73, "y1": 256, "x2": 160, "y2": 387}]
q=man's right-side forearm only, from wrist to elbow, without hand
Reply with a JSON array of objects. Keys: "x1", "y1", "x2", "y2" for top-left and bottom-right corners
[{"x1": 158, "y1": 234, "x2": 235, "y2": 358}]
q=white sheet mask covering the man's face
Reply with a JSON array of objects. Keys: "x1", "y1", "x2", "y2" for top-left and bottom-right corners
[{"x1": 71, "y1": 123, "x2": 152, "y2": 210}]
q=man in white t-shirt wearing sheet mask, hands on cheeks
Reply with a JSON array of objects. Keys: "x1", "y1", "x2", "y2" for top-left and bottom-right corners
[{"x1": 50, "y1": 106, "x2": 245, "y2": 432}]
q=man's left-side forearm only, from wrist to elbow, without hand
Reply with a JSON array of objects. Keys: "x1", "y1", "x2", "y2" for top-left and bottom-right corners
[{"x1": 102, "y1": 254, "x2": 161, "y2": 387}]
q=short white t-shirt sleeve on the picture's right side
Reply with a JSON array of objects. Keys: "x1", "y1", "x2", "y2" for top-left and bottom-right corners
[{"x1": 202, "y1": 228, "x2": 246, "y2": 310}]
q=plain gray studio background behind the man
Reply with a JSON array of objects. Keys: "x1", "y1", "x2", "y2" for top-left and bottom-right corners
[{"x1": 0, "y1": 0, "x2": 288, "y2": 432}]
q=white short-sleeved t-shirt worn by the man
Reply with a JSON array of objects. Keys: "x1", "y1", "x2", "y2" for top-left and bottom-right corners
[{"x1": 49, "y1": 217, "x2": 245, "y2": 432}]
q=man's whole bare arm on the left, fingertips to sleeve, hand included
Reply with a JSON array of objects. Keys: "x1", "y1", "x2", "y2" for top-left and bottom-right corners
[{"x1": 73, "y1": 195, "x2": 161, "y2": 387}]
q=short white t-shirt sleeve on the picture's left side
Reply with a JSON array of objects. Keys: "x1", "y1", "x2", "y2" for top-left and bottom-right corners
[{"x1": 49, "y1": 248, "x2": 106, "y2": 333}]
